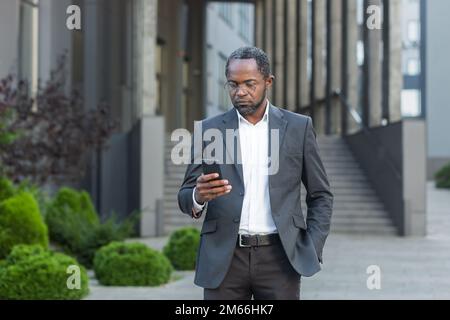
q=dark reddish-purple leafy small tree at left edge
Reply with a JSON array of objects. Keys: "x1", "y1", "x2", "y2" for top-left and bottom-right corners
[{"x1": 0, "y1": 55, "x2": 116, "y2": 185}]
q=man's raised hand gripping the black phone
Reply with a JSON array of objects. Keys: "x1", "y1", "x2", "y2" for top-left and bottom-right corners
[{"x1": 195, "y1": 173, "x2": 232, "y2": 204}]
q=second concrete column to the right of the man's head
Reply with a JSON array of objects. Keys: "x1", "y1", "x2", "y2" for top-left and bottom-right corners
[{"x1": 284, "y1": 0, "x2": 299, "y2": 111}]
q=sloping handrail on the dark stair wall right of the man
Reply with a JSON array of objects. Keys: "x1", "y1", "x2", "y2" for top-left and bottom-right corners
[{"x1": 331, "y1": 89, "x2": 402, "y2": 181}]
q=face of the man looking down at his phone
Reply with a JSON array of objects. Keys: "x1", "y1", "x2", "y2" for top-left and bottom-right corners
[{"x1": 227, "y1": 59, "x2": 273, "y2": 116}]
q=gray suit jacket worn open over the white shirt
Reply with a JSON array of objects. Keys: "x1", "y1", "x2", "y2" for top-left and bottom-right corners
[{"x1": 178, "y1": 105, "x2": 333, "y2": 289}]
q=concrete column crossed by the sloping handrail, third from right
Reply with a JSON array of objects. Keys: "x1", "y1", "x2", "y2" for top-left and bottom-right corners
[{"x1": 341, "y1": 0, "x2": 358, "y2": 133}]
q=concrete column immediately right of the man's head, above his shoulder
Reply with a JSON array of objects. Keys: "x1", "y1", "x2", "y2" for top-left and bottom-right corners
[{"x1": 273, "y1": 0, "x2": 286, "y2": 108}]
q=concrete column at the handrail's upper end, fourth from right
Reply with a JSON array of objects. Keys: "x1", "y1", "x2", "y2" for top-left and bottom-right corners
[{"x1": 326, "y1": 0, "x2": 342, "y2": 134}]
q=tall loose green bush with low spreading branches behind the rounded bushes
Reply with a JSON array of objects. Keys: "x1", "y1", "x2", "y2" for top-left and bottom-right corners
[{"x1": 45, "y1": 188, "x2": 136, "y2": 268}]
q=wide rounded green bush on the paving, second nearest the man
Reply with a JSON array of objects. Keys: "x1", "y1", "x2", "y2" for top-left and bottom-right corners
[{"x1": 94, "y1": 242, "x2": 172, "y2": 286}]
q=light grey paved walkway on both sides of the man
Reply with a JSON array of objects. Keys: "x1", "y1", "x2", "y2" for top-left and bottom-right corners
[{"x1": 88, "y1": 183, "x2": 450, "y2": 300}]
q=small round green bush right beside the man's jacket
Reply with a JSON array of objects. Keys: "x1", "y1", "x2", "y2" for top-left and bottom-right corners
[{"x1": 163, "y1": 227, "x2": 200, "y2": 270}]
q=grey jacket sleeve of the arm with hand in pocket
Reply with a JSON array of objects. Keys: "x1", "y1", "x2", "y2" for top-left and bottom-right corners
[{"x1": 302, "y1": 117, "x2": 333, "y2": 263}]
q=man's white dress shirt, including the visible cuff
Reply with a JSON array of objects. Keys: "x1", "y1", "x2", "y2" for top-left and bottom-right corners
[{"x1": 192, "y1": 100, "x2": 277, "y2": 234}]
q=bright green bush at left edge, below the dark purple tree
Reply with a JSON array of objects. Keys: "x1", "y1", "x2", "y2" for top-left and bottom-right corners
[{"x1": 0, "y1": 192, "x2": 48, "y2": 259}]
